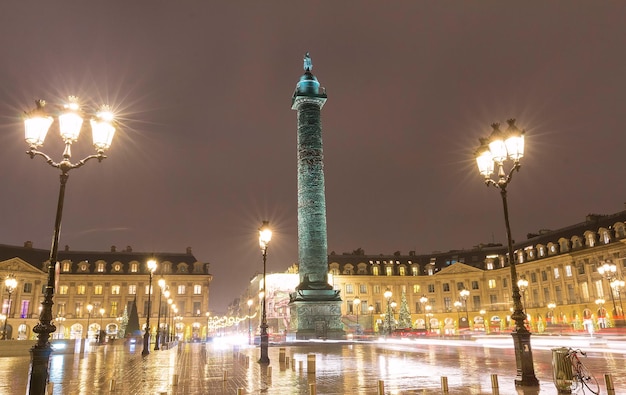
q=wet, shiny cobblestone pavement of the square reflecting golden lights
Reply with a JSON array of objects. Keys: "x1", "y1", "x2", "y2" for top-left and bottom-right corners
[{"x1": 0, "y1": 341, "x2": 626, "y2": 395}]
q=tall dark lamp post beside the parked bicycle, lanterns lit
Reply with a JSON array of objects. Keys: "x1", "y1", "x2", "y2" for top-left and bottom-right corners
[{"x1": 476, "y1": 119, "x2": 539, "y2": 386}]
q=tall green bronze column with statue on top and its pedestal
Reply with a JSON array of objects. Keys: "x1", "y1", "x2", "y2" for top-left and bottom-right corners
[{"x1": 289, "y1": 53, "x2": 345, "y2": 339}]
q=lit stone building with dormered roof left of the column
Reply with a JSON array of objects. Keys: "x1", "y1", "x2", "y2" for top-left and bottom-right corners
[{"x1": 0, "y1": 242, "x2": 212, "y2": 340}]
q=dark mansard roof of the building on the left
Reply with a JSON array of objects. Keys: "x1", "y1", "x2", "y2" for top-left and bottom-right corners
[{"x1": 0, "y1": 242, "x2": 209, "y2": 274}]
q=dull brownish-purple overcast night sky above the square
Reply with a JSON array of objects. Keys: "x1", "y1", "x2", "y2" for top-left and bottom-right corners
[{"x1": 0, "y1": 0, "x2": 626, "y2": 312}]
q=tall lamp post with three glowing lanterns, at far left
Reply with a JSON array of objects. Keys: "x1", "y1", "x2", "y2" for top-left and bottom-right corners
[{"x1": 24, "y1": 96, "x2": 115, "y2": 394}]
